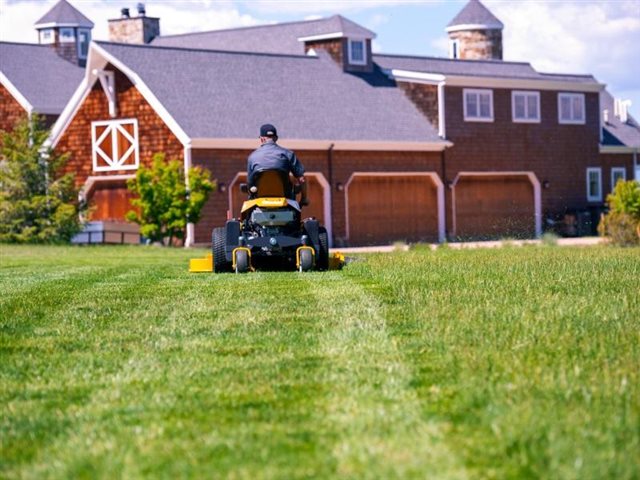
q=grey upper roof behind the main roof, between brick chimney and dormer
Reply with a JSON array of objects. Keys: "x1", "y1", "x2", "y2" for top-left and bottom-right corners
[{"x1": 152, "y1": 15, "x2": 376, "y2": 55}]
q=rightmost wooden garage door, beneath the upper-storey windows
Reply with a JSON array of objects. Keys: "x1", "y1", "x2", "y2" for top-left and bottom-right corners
[{"x1": 454, "y1": 174, "x2": 535, "y2": 239}]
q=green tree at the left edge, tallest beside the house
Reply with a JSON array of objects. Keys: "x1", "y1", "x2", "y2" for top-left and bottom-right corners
[{"x1": 0, "y1": 115, "x2": 85, "y2": 243}]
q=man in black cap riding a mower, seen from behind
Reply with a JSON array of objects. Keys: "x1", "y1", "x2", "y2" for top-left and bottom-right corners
[{"x1": 212, "y1": 124, "x2": 329, "y2": 273}]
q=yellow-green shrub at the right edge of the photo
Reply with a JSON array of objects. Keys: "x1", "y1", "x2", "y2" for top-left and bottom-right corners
[{"x1": 598, "y1": 180, "x2": 640, "y2": 246}]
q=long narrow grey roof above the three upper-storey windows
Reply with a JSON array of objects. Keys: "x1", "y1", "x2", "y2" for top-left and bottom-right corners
[{"x1": 373, "y1": 54, "x2": 597, "y2": 83}]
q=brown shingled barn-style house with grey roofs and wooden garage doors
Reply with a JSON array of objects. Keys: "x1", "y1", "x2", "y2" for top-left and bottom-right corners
[{"x1": 2, "y1": 0, "x2": 640, "y2": 246}]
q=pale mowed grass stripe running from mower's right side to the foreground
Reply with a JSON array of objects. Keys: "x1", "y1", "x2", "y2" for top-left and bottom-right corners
[{"x1": 305, "y1": 272, "x2": 466, "y2": 479}]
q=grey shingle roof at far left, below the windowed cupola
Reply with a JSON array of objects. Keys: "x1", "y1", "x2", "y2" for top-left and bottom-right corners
[{"x1": 0, "y1": 42, "x2": 84, "y2": 115}]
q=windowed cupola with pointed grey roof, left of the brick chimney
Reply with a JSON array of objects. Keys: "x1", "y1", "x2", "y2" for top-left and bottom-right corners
[{"x1": 35, "y1": 0, "x2": 93, "y2": 67}]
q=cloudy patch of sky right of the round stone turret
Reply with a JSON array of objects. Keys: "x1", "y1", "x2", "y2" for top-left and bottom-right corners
[{"x1": 485, "y1": 0, "x2": 640, "y2": 111}]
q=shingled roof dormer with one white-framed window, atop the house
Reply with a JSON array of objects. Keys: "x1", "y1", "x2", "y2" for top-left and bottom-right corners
[{"x1": 298, "y1": 15, "x2": 376, "y2": 72}]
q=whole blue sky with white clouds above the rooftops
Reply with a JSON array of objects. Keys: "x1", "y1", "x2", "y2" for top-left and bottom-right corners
[{"x1": 0, "y1": 0, "x2": 640, "y2": 117}]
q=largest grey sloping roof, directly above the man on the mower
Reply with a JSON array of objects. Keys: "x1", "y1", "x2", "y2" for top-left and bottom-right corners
[{"x1": 98, "y1": 42, "x2": 441, "y2": 142}]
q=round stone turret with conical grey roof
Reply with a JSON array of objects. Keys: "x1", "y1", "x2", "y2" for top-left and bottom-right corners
[{"x1": 447, "y1": 0, "x2": 504, "y2": 60}]
